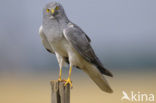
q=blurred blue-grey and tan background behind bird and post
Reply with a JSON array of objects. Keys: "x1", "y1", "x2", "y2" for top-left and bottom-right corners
[{"x1": 0, "y1": 0, "x2": 156, "y2": 103}]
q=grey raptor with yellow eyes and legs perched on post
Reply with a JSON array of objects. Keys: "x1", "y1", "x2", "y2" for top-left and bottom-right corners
[{"x1": 39, "y1": 2, "x2": 113, "y2": 93}]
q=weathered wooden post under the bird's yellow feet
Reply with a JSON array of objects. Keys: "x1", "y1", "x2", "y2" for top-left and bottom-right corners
[{"x1": 50, "y1": 80, "x2": 70, "y2": 103}]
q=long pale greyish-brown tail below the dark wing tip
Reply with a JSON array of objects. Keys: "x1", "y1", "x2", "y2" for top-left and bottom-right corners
[{"x1": 83, "y1": 64, "x2": 113, "y2": 93}]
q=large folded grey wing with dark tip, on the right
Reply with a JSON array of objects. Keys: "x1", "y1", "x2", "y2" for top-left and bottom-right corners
[{"x1": 63, "y1": 24, "x2": 113, "y2": 77}]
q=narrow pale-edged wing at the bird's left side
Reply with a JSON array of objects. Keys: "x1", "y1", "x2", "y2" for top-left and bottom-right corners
[{"x1": 39, "y1": 26, "x2": 54, "y2": 54}]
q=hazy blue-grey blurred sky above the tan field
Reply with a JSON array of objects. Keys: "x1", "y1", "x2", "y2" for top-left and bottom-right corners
[{"x1": 0, "y1": 0, "x2": 156, "y2": 72}]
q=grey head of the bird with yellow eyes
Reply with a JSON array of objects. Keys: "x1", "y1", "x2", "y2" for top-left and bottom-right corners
[{"x1": 43, "y1": 2, "x2": 66, "y2": 19}]
